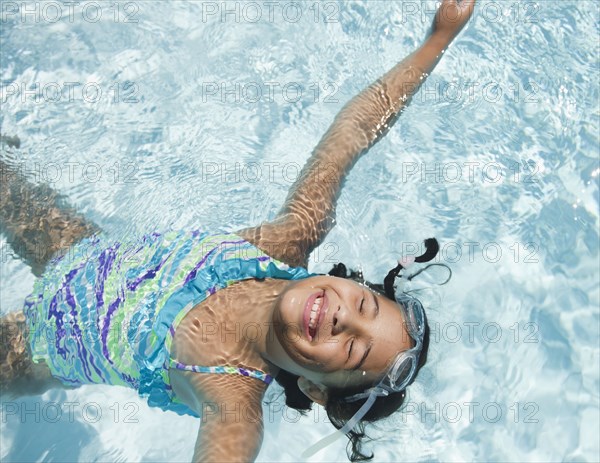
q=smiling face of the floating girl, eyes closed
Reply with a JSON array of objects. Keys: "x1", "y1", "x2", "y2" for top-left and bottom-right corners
[{"x1": 273, "y1": 276, "x2": 414, "y2": 388}]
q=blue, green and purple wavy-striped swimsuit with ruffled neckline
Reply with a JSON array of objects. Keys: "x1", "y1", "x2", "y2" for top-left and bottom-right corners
[{"x1": 24, "y1": 231, "x2": 311, "y2": 416}]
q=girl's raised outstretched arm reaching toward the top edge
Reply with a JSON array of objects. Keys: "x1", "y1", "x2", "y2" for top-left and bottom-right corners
[{"x1": 238, "y1": 0, "x2": 476, "y2": 266}]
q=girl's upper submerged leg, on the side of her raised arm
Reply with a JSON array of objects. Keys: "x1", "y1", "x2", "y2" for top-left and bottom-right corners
[{"x1": 0, "y1": 152, "x2": 100, "y2": 277}]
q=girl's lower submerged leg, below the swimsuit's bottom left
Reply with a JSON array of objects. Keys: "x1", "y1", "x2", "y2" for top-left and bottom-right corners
[{"x1": 0, "y1": 312, "x2": 64, "y2": 399}]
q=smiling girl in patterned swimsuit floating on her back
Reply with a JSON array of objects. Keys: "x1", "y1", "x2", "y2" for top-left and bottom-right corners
[{"x1": 0, "y1": 0, "x2": 475, "y2": 461}]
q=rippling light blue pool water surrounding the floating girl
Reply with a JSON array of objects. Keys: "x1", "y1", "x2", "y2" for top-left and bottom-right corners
[{"x1": 0, "y1": 0, "x2": 600, "y2": 462}]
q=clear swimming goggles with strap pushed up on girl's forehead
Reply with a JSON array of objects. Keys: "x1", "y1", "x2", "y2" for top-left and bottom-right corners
[{"x1": 302, "y1": 238, "x2": 439, "y2": 458}]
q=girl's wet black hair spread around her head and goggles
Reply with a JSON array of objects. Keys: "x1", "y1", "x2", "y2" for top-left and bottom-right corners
[{"x1": 275, "y1": 256, "x2": 439, "y2": 462}]
